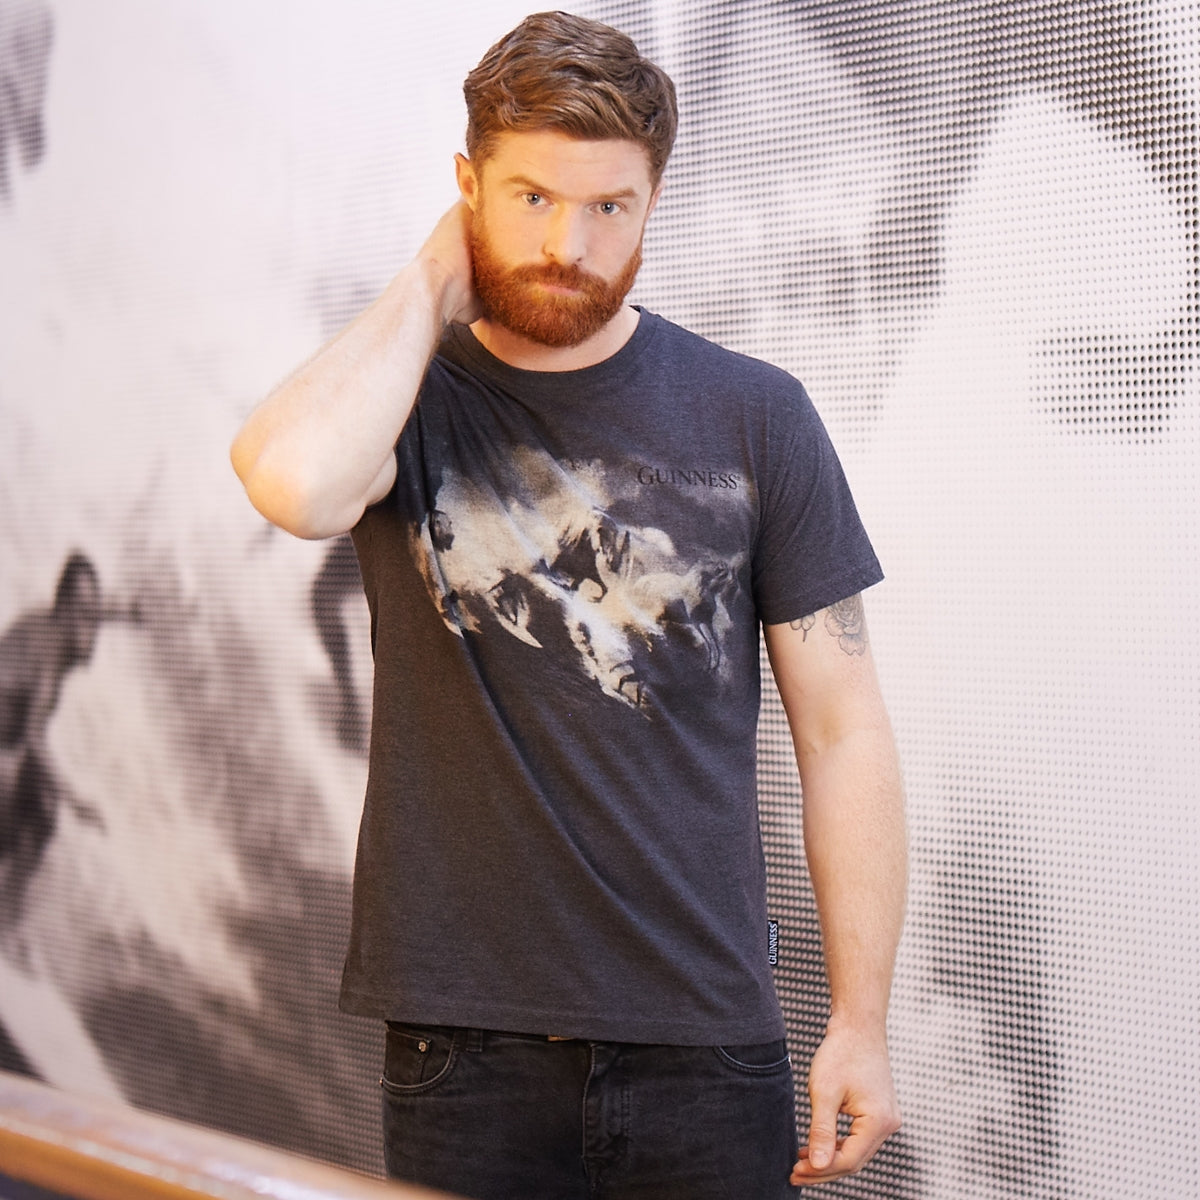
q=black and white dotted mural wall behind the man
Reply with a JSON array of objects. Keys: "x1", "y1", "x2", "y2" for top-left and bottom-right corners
[{"x1": 0, "y1": 0, "x2": 1200, "y2": 1200}]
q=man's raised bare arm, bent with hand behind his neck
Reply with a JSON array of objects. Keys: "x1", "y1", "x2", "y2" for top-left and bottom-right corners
[{"x1": 230, "y1": 202, "x2": 479, "y2": 538}]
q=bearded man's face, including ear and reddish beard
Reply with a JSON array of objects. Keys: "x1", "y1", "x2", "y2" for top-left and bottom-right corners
[{"x1": 460, "y1": 131, "x2": 658, "y2": 348}]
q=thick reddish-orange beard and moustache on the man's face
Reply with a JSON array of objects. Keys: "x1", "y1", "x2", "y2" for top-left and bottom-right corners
[{"x1": 470, "y1": 212, "x2": 642, "y2": 349}]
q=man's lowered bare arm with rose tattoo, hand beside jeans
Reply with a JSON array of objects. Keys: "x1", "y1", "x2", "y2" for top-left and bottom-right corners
[{"x1": 764, "y1": 596, "x2": 907, "y2": 1184}]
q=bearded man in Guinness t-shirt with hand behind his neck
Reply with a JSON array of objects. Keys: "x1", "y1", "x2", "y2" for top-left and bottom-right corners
[{"x1": 233, "y1": 13, "x2": 905, "y2": 1200}]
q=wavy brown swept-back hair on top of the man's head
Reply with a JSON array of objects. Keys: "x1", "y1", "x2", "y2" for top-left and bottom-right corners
[{"x1": 462, "y1": 12, "x2": 678, "y2": 184}]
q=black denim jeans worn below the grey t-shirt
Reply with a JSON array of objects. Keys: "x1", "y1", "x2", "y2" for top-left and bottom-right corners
[{"x1": 382, "y1": 1022, "x2": 797, "y2": 1200}]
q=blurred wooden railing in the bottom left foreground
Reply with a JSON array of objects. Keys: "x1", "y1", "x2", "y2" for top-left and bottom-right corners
[{"x1": 0, "y1": 1072, "x2": 445, "y2": 1200}]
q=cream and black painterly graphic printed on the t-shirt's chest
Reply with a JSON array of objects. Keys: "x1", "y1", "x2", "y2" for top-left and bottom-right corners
[{"x1": 414, "y1": 449, "x2": 744, "y2": 710}]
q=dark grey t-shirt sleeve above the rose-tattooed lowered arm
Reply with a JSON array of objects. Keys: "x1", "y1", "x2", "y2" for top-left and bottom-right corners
[{"x1": 754, "y1": 384, "x2": 883, "y2": 625}]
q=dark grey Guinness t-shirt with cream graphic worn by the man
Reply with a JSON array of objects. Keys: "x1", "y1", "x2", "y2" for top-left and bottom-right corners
[{"x1": 342, "y1": 312, "x2": 881, "y2": 1045}]
